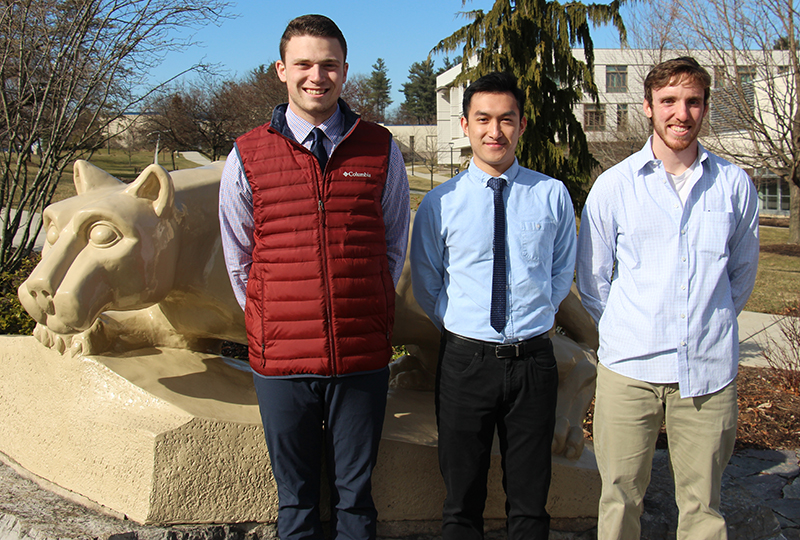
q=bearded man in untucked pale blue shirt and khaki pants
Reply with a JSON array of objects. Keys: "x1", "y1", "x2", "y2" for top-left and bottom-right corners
[{"x1": 577, "y1": 57, "x2": 759, "y2": 540}]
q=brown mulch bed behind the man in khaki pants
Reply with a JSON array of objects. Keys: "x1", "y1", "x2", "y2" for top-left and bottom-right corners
[{"x1": 584, "y1": 366, "x2": 800, "y2": 450}]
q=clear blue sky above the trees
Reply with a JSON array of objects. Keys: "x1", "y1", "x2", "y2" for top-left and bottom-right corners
[{"x1": 150, "y1": 0, "x2": 617, "y2": 109}]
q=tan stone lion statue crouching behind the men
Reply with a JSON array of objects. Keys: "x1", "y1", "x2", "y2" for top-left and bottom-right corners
[{"x1": 19, "y1": 161, "x2": 597, "y2": 458}]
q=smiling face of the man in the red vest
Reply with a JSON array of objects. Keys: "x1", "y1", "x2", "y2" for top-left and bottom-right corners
[{"x1": 275, "y1": 36, "x2": 347, "y2": 126}]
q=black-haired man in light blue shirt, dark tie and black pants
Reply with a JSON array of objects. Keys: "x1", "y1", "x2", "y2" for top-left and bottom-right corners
[{"x1": 410, "y1": 73, "x2": 577, "y2": 540}]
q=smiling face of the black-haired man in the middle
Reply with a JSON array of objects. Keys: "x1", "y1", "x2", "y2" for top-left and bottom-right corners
[{"x1": 461, "y1": 92, "x2": 527, "y2": 176}]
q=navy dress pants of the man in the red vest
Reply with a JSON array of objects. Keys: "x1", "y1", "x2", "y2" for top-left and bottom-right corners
[{"x1": 254, "y1": 368, "x2": 389, "y2": 540}]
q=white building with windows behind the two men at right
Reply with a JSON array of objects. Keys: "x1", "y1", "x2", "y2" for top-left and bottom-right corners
[{"x1": 436, "y1": 49, "x2": 797, "y2": 215}]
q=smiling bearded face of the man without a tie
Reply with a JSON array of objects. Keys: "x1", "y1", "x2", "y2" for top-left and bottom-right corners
[{"x1": 644, "y1": 78, "x2": 708, "y2": 160}]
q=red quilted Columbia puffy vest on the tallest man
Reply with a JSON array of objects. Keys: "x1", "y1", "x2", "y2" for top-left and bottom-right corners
[{"x1": 236, "y1": 115, "x2": 395, "y2": 376}]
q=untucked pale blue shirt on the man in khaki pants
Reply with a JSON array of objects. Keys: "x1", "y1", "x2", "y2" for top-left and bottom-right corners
[{"x1": 577, "y1": 141, "x2": 759, "y2": 398}]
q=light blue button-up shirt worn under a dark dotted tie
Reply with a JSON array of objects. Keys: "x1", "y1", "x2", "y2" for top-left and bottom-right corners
[{"x1": 410, "y1": 160, "x2": 577, "y2": 343}]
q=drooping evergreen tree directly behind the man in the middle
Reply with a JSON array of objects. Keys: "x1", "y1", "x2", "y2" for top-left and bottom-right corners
[{"x1": 434, "y1": 0, "x2": 625, "y2": 207}]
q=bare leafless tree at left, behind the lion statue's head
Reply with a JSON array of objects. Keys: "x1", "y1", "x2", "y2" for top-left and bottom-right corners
[{"x1": 0, "y1": 0, "x2": 228, "y2": 270}]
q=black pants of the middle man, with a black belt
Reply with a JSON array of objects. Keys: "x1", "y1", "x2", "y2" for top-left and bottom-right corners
[{"x1": 436, "y1": 332, "x2": 558, "y2": 540}]
